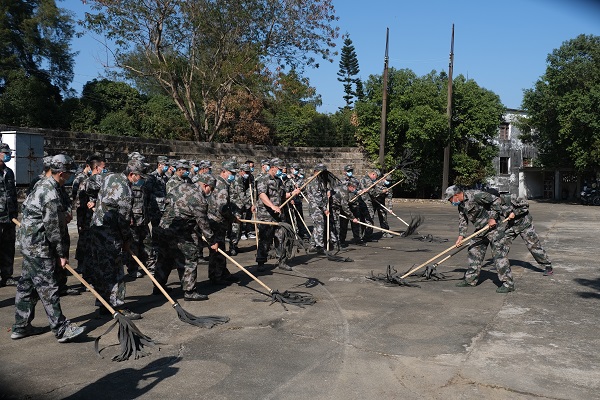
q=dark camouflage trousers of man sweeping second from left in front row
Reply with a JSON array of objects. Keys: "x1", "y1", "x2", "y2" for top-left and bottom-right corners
[{"x1": 89, "y1": 226, "x2": 125, "y2": 307}]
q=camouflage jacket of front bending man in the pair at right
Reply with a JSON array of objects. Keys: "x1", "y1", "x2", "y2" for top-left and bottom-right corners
[{"x1": 458, "y1": 190, "x2": 502, "y2": 237}]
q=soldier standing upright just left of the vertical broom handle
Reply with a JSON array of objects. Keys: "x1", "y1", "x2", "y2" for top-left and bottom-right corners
[{"x1": 305, "y1": 164, "x2": 329, "y2": 254}]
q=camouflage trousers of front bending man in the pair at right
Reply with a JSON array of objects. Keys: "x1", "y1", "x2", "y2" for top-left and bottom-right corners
[{"x1": 465, "y1": 229, "x2": 515, "y2": 288}]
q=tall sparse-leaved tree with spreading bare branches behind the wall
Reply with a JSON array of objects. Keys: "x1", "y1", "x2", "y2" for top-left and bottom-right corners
[{"x1": 86, "y1": 0, "x2": 337, "y2": 141}]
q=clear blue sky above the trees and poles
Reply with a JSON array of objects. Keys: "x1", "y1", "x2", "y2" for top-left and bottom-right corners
[{"x1": 68, "y1": 0, "x2": 600, "y2": 113}]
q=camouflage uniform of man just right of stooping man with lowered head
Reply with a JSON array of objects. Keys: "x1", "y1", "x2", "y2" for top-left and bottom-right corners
[{"x1": 208, "y1": 176, "x2": 235, "y2": 283}]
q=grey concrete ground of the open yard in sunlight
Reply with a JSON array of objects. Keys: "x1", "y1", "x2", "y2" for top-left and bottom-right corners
[{"x1": 0, "y1": 200, "x2": 600, "y2": 400}]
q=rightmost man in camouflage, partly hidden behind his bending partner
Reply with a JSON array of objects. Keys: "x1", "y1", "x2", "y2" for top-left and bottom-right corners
[{"x1": 500, "y1": 194, "x2": 554, "y2": 276}]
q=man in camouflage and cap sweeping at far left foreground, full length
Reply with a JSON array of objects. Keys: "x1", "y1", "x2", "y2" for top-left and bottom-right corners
[{"x1": 11, "y1": 154, "x2": 84, "y2": 343}]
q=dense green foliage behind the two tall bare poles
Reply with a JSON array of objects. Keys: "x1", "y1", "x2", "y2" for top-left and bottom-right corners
[{"x1": 356, "y1": 68, "x2": 504, "y2": 196}]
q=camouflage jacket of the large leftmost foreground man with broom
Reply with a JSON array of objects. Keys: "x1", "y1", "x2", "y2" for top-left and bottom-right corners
[{"x1": 18, "y1": 177, "x2": 69, "y2": 258}]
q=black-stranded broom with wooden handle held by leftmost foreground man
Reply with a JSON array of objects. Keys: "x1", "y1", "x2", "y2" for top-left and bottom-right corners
[{"x1": 12, "y1": 218, "x2": 156, "y2": 361}]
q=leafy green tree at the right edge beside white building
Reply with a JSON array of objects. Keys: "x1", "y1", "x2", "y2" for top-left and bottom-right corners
[{"x1": 521, "y1": 35, "x2": 600, "y2": 171}]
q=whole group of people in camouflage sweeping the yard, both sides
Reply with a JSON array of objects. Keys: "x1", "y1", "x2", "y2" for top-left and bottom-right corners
[{"x1": 0, "y1": 140, "x2": 552, "y2": 342}]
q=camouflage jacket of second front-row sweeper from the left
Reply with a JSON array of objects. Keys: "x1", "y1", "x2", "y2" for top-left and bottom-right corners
[{"x1": 92, "y1": 173, "x2": 133, "y2": 241}]
